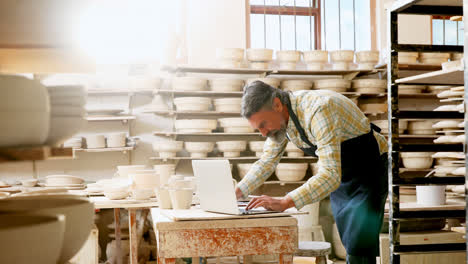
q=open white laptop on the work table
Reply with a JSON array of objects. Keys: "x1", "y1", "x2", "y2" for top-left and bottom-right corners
[{"x1": 192, "y1": 160, "x2": 278, "y2": 215}]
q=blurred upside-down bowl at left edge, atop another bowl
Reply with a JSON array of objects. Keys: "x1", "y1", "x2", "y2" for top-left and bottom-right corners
[{"x1": 0, "y1": 75, "x2": 50, "y2": 111}]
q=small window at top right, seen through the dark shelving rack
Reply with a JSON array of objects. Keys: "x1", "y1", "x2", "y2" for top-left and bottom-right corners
[{"x1": 432, "y1": 16, "x2": 464, "y2": 45}]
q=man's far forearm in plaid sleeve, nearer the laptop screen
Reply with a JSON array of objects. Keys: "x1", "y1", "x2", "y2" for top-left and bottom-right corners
[{"x1": 236, "y1": 138, "x2": 288, "y2": 199}]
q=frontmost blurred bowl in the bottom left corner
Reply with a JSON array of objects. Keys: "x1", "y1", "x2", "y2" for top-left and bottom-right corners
[{"x1": 0, "y1": 214, "x2": 65, "y2": 264}]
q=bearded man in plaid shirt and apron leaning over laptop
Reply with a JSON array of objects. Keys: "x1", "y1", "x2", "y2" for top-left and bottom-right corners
[{"x1": 236, "y1": 81, "x2": 388, "y2": 264}]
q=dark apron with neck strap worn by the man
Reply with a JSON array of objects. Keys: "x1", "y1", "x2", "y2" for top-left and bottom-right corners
[{"x1": 287, "y1": 100, "x2": 388, "y2": 263}]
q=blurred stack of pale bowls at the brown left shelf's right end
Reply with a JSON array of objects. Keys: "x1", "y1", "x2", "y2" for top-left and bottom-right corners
[{"x1": 46, "y1": 86, "x2": 86, "y2": 146}]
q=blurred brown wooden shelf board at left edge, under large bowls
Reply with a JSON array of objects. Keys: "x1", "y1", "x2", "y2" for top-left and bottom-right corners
[{"x1": 0, "y1": 146, "x2": 73, "y2": 163}]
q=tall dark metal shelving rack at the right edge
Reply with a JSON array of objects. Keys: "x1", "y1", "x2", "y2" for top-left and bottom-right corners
[{"x1": 387, "y1": 0, "x2": 468, "y2": 264}]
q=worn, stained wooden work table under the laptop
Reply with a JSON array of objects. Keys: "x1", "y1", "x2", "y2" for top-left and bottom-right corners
[{"x1": 151, "y1": 208, "x2": 298, "y2": 264}]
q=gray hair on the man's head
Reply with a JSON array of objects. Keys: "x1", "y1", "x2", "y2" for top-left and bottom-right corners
[{"x1": 241, "y1": 81, "x2": 289, "y2": 118}]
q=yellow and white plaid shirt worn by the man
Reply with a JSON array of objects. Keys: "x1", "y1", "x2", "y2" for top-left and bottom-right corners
[{"x1": 238, "y1": 90, "x2": 387, "y2": 209}]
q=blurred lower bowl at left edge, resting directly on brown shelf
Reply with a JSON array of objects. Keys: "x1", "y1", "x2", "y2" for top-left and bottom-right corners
[{"x1": 0, "y1": 111, "x2": 50, "y2": 147}]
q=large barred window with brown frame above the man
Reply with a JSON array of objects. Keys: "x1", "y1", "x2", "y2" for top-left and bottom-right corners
[{"x1": 249, "y1": 0, "x2": 375, "y2": 50}]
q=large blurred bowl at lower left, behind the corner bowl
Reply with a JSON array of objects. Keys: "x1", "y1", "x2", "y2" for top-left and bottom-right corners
[{"x1": 0, "y1": 195, "x2": 94, "y2": 263}]
